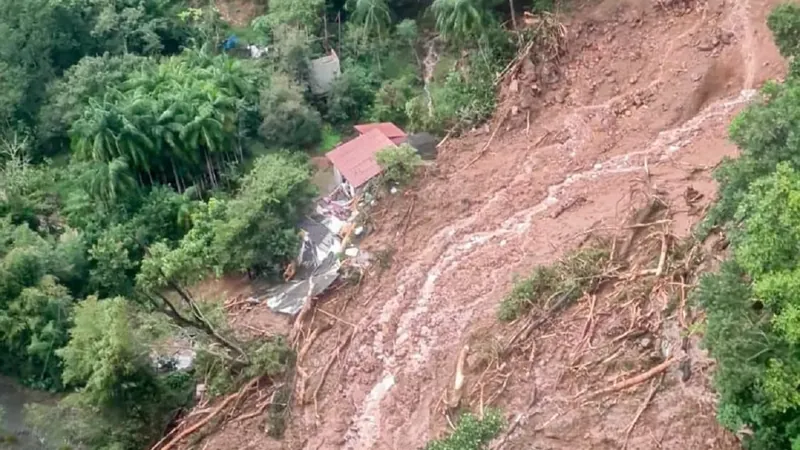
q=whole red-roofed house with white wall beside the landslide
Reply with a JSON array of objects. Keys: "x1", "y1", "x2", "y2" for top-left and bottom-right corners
[{"x1": 325, "y1": 122, "x2": 407, "y2": 195}]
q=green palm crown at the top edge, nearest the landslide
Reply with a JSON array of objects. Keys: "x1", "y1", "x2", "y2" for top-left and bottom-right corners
[{"x1": 431, "y1": 0, "x2": 488, "y2": 41}]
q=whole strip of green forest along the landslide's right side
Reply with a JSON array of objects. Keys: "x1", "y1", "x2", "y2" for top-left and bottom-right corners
[{"x1": 696, "y1": 4, "x2": 800, "y2": 450}]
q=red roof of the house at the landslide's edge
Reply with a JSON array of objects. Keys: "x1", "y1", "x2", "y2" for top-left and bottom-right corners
[{"x1": 325, "y1": 130, "x2": 395, "y2": 188}]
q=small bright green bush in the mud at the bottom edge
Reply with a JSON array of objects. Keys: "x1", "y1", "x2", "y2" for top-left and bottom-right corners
[{"x1": 425, "y1": 410, "x2": 506, "y2": 450}]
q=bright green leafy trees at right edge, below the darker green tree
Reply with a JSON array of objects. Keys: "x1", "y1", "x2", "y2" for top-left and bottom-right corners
[{"x1": 697, "y1": 164, "x2": 800, "y2": 449}]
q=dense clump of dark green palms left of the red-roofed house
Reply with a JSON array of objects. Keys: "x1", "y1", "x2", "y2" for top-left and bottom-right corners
[{"x1": 70, "y1": 51, "x2": 257, "y2": 193}]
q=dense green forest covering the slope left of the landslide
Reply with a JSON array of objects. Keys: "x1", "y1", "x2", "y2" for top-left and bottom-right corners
[{"x1": 0, "y1": 0, "x2": 524, "y2": 449}]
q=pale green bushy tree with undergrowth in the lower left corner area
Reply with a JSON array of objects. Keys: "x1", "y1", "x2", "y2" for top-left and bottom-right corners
[{"x1": 53, "y1": 297, "x2": 191, "y2": 450}]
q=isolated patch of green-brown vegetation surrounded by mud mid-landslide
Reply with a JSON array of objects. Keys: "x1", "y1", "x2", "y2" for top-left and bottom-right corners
[{"x1": 497, "y1": 246, "x2": 610, "y2": 322}]
